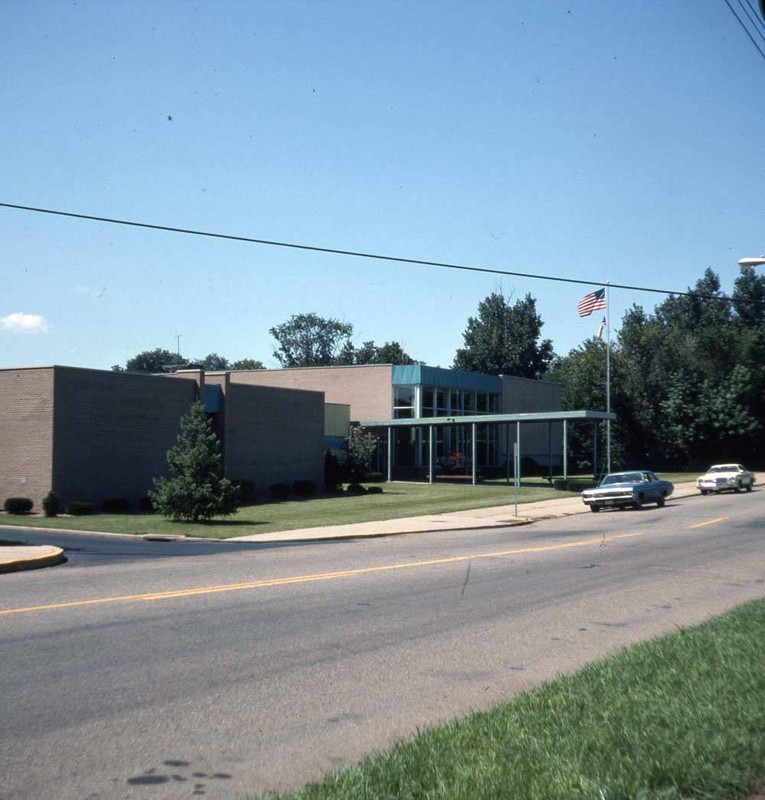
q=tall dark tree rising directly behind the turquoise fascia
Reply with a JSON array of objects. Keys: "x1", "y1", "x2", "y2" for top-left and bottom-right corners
[{"x1": 454, "y1": 292, "x2": 555, "y2": 378}]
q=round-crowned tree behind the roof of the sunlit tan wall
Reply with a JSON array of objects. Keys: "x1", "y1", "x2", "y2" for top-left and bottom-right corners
[{"x1": 268, "y1": 314, "x2": 353, "y2": 367}]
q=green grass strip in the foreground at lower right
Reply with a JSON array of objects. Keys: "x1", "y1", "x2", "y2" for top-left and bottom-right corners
[{"x1": 252, "y1": 600, "x2": 765, "y2": 800}]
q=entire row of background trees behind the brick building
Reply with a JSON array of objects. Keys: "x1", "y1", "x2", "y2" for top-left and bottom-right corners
[{"x1": 114, "y1": 267, "x2": 765, "y2": 470}]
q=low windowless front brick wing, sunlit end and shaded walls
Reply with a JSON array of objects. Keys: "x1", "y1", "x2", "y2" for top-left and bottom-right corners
[{"x1": 0, "y1": 366, "x2": 325, "y2": 508}]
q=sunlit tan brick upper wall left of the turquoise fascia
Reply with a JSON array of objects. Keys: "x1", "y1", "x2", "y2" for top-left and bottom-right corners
[{"x1": 222, "y1": 364, "x2": 393, "y2": 421}]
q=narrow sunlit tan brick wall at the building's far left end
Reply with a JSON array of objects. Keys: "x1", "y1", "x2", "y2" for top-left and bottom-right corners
[{"x1": 0, "y1": 367, "x2": 53, "y2": 511}]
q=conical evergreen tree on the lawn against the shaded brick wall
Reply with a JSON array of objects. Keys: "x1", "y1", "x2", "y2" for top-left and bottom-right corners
[{"x1": 149, "y1": 403, "x2": 239, "y2": 522}]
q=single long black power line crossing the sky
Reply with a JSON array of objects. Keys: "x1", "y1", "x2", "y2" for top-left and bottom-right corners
[{"x1": 0, "y1": 202, "x2": 756, "y2": 302}]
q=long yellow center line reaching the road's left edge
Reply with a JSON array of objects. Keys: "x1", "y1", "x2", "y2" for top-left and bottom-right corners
[{"x1": 0, "y1": 532, "x2": 645, "y2": 616}]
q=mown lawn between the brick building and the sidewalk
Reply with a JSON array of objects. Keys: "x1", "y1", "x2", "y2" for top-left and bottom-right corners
[{"x1": 0, "y1": 474, "x2": 695, "y2": 539}]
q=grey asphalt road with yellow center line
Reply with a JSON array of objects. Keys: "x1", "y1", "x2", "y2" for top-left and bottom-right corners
[{"x1": 0, "y1": 490, "x2": 765, "y2": 800}]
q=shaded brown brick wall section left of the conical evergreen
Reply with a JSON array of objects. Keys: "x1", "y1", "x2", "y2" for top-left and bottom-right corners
[{"x1": 53, "y1": 367, "x2": 197, "y2": 504}]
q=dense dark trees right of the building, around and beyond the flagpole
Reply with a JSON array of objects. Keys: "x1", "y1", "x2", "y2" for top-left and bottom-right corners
[{"x1": 546, "y1": 268, "x2": 765, "y2": 469}]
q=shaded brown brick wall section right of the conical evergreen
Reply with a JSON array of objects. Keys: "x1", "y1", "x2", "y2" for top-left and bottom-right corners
[{"x1": 207, "y1": 375, "x2": 324, "y2": 494}]
